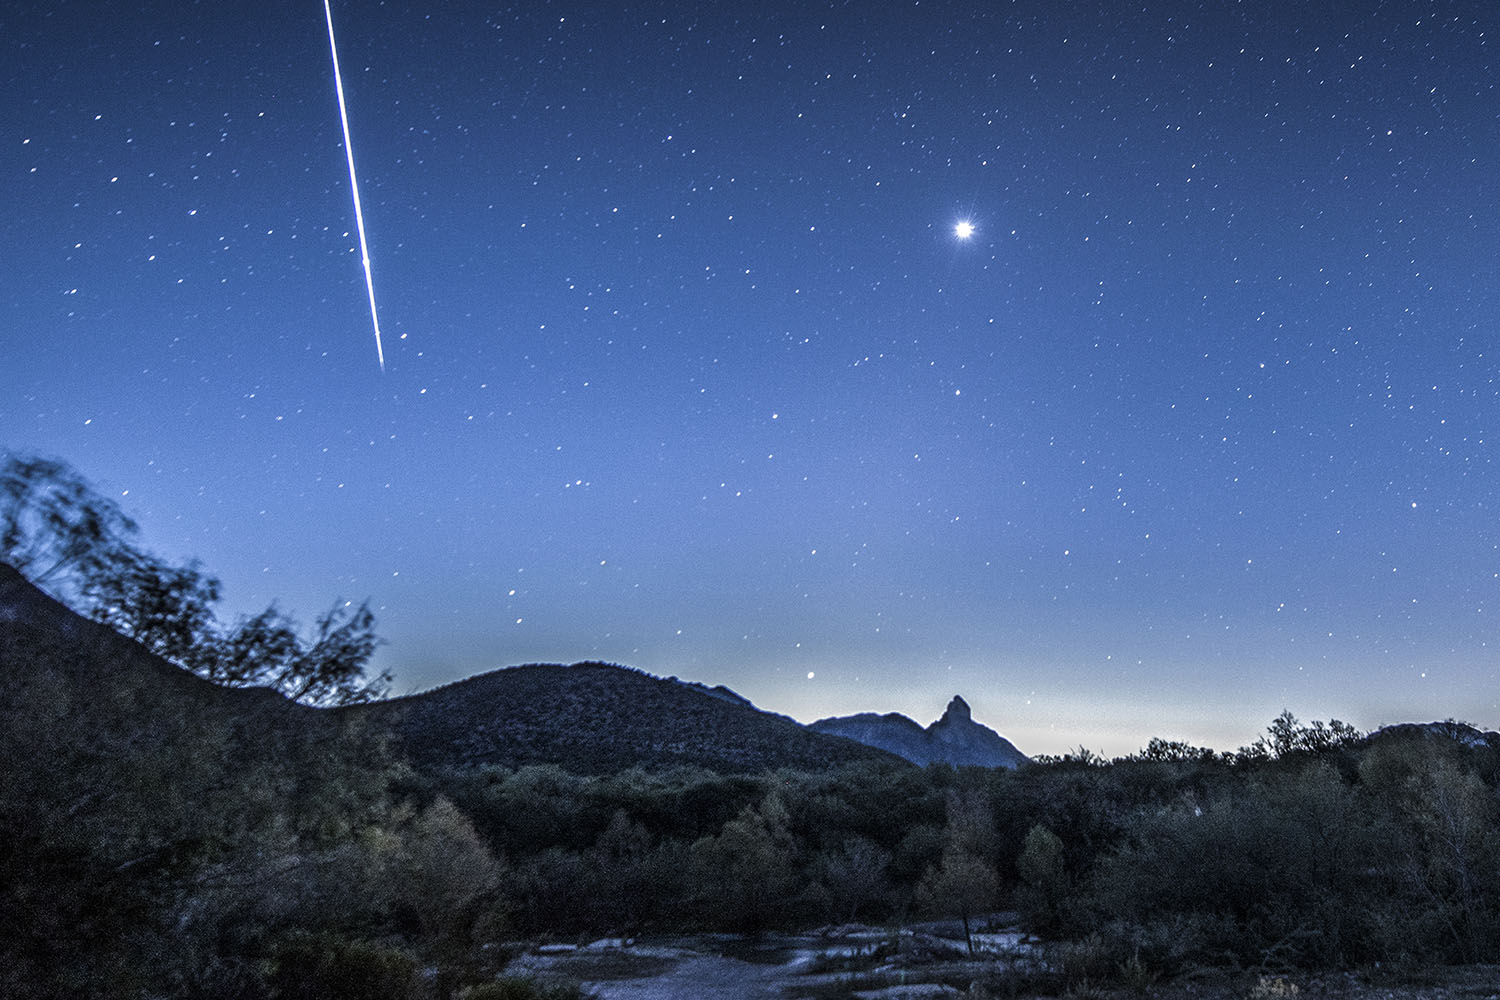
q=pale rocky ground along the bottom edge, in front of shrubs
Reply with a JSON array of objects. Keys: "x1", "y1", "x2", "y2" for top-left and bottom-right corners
[{"x1": 507, "y1": 925, "x2": 1500, "y2": 1000}]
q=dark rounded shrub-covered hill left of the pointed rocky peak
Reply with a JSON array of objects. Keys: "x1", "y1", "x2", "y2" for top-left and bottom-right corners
[{"x1": 333, "y1": 663, "x2": 893, "y2": 774}]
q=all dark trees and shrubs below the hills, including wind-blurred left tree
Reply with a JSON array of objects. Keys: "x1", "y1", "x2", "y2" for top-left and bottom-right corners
[{"x1": 0, "y1": 463, "x2": 1500, "y2": 1000}]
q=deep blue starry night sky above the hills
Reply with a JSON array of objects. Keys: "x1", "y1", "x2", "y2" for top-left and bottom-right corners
[{"x1": 0, "y1": 0, "x2": 1500, "y2": 753}]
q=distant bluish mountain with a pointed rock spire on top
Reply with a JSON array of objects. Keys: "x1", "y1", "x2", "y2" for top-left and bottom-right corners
[{"x1": 809, "y1": 694, "x2": 1031, "y2": 768}]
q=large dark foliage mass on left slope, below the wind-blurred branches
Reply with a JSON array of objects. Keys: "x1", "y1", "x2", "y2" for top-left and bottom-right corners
[{"x1": 0, "y1": 568, "x2": 411, "y2": 997}]
